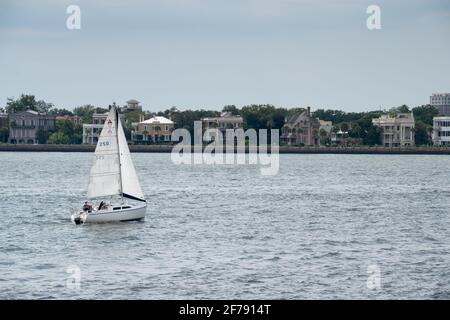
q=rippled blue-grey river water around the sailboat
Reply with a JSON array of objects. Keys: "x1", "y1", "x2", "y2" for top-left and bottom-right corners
[{"x1": 0, "y1": 152, "x2": 450, "y2": 299}]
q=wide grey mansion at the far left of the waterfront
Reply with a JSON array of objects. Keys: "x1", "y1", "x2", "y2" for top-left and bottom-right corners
[{"x1": 8, "y1": 110, "x2": 55, "y2": 144}]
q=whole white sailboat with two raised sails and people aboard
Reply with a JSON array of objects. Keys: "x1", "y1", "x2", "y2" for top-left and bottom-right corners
[{"x1": 71, "y1": 105, "x2": 147, "y2": 224}]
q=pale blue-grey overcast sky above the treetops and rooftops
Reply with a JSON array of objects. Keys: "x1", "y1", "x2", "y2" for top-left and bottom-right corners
[{"x1": 0, "y1": 0, "x2": 450, "y2": 111}]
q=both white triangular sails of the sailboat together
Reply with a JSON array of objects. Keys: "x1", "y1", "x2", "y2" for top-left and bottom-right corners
[{"x1": 87, "y1": 107, "x2": 145, "y2": 201}]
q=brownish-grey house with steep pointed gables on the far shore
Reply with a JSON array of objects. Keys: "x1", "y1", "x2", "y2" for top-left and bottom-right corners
[{"x1": 280, "y1": 107, "x2": 320, "y2": 146}]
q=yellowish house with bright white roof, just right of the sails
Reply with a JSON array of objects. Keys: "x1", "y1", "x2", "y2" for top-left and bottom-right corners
[{"x1": 131, "y1": 115, "x2": 175, "y2": 143}]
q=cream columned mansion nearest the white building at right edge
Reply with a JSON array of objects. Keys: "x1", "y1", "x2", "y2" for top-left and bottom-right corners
[{"x1": 372, "y1": 112, "x2": 415, "y2": 147}]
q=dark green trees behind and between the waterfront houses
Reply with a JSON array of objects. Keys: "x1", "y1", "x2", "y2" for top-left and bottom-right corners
[{"x1": 0, "y1": 95, "x2": 438, "y2": 145}]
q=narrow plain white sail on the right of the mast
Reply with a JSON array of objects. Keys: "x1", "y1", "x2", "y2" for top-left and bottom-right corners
[{"x1": 118, "y1": 121, "x2": 145, "y2": 201}]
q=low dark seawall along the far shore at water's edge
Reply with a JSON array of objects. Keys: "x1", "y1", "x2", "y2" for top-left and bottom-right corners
[{"x1": 0, "y1": 144, "x2": 450, "y2": 155}]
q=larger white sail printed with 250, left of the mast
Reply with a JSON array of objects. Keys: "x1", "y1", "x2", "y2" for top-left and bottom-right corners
[{"x1": 87, "y1": 107, "x2": 121, "y2": 198}]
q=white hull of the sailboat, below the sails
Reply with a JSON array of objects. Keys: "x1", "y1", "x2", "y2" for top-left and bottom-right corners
[{"x1": 72, "y1": 204, "x2": 147, "y2": 224}]
